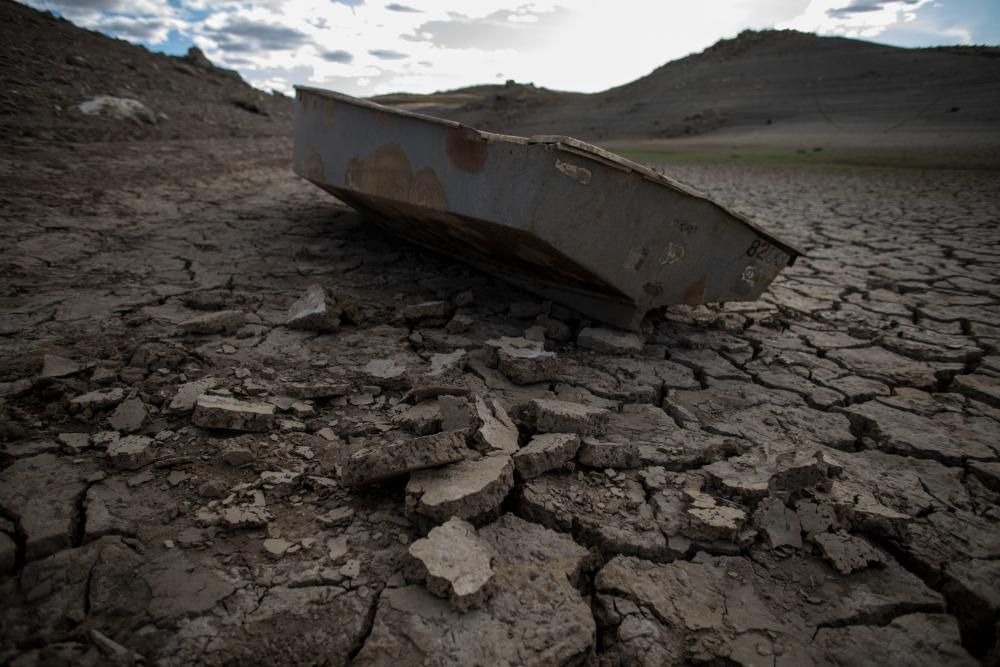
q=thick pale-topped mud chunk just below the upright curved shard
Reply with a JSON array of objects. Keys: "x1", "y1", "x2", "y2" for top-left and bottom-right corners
[{"x1": 406, "y1": 452, "x2": 514, "y2": 523}]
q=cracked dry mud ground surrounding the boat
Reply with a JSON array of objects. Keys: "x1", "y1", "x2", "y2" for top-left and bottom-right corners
[{"x1": 0, "y1": 138, "x2": 1000, "y2": 666}]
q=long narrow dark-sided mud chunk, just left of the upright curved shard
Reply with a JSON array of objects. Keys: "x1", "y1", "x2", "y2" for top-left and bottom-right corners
[{"x1": 341, "y1": 432, "x2": 468, "y2": 486}]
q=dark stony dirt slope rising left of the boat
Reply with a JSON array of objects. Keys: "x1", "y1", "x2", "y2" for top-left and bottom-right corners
[{"x1": 0, "y1": 0, "x2": 292, "y2": 143}]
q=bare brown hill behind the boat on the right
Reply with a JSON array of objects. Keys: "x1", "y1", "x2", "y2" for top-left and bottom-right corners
[{"x1": 389, "y1": 30, "x2": 1000, "y2": 140}]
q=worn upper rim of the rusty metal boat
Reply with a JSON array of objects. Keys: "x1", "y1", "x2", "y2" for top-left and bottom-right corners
[{"x1": 295, "y1": 86, "x2": 805, "y2": 266}]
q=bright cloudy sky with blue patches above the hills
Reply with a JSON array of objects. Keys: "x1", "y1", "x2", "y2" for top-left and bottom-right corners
[{"x1": 23, "y1": 0, "x2": 1000, "y2": 95}]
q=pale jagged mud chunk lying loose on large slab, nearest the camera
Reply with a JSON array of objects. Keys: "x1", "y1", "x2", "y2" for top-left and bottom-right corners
[{"x1": 409, "y1": 518, "x2": 496, "y2": 611}]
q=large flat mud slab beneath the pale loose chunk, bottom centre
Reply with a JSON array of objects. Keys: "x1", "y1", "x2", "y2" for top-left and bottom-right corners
[{"x1": 355, "y1": 514, "x2": 596, "y2": 665}]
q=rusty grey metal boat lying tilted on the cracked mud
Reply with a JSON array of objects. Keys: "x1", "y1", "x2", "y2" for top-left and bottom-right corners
[{"x1": 294, "y1": 87, "x2": 800, "y2": 330}]
